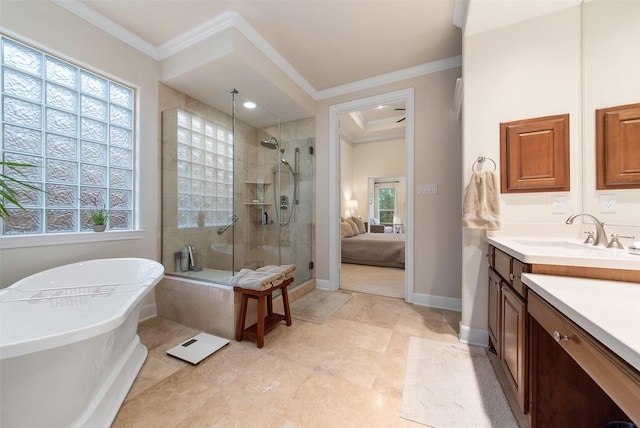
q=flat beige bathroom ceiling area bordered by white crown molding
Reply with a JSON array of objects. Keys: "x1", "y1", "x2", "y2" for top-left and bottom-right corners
[{"x1": 74, "y1": 0, "x2": 462, "y2": 91}]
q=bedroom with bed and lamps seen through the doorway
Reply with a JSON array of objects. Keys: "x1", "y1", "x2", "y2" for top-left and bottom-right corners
[{"x1": 339, "y1": 101, "x2": 407, "y2": 299}]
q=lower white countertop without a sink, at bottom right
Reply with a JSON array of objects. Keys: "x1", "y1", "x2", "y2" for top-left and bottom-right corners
[{"x1": 522, "y1": 273, "x2": 640, "y2": 371}]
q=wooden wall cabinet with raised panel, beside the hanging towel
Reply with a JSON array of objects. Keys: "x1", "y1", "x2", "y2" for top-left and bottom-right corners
[{"x1": 500, "y1": 114, "x2": 570, "y2": 193}]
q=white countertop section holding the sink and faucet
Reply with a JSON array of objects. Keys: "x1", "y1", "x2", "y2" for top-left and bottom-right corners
[{"x1": 485, "y1": 236, "x2": 640, "y2": 270}]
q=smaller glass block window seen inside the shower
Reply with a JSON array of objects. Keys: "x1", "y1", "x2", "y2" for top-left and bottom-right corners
[{"x1": 177, "y1": 109, "x2": 233, "y2": 228}]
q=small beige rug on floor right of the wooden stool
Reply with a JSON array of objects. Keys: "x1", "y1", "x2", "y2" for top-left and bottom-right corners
[{"x1": 291, "y1": 288, "x2": 351, "y2": 324}]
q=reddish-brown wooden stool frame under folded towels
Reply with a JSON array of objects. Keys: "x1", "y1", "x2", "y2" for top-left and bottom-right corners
[{"x1": 233, "y1": 278, "x2": 293, "y2": 348}]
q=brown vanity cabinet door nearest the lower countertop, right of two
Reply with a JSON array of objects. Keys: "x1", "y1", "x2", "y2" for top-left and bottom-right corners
[{"x1": 501, "y1": 285, "x2": 528, "y2": 413}]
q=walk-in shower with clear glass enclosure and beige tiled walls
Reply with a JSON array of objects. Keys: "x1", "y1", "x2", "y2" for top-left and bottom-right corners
[{"x1": 162, "y1": 90, "x2": 313, "y2": 287}]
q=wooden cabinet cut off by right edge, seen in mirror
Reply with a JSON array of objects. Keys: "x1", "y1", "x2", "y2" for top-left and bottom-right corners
[{"x1": 596, "y1": 104, "x2": 640, "y2": 190}]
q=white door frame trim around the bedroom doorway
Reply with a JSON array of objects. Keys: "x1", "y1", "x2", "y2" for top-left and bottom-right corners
[{"x1": 329, "y1": 88, "x2": 414, "y2": 303}]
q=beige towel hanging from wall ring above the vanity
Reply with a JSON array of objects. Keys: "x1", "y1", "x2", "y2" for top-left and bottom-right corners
[{"x1": 462, "y1": 171, "x2": 500, "y2": 230}]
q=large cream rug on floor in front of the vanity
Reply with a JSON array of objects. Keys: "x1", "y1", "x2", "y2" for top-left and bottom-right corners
[{"x1": 400, "y1": 337, "x2": 518, "y2": 428}]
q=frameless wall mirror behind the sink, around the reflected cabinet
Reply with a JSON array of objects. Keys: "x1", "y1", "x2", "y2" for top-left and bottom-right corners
[{"x1": 582, "y1": 0, "x2": 640, "y2": 226}]
